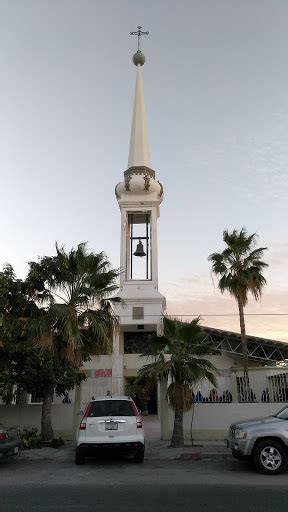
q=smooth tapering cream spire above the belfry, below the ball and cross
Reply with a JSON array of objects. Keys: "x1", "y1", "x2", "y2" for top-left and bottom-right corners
[{"x1": 128, "y1": 60, "x2": 150, "y2": 169}]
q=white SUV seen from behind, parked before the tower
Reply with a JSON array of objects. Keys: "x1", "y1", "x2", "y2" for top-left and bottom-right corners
[{"x1": 75, "y1": 396, "x2": 145, "y2": 464}]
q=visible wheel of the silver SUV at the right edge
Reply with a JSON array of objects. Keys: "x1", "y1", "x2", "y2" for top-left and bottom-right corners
[{"x1": 253, "y1": 439, "x2": 287, "y2": 475}]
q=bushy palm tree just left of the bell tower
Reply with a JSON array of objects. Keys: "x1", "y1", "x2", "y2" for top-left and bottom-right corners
[{"x1": 26, "y1": 243, "x2": 119, "y2": 438}]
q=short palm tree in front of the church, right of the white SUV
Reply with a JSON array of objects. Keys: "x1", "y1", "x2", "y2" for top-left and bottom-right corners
[{"x1": 137, "y1": 317, "x2": 217, "y2": 448}]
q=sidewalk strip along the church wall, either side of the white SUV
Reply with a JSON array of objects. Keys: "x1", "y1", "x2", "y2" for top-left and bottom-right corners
[{"x1": 20, "y1": 439, "x2": 230, "y2": 462}]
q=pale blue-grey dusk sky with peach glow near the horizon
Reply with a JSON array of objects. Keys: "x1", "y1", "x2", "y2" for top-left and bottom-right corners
[{"x1": 0, "y1": 0, "x2": 288, "y2": 341}]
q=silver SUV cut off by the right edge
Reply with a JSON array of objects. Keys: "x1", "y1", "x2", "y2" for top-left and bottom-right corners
[{"x1": 225, "y1": 407, "x2": 288, "y2": 475}]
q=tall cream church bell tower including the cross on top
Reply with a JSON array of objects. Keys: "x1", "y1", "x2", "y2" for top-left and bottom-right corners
[{"x1": 113, "y1": 27, "x2": 165, "y2": 393}]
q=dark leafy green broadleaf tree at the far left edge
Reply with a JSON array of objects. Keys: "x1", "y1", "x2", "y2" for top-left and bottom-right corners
[{"x1": 0, "y1": 265, "x2": 85, "y2": 441}]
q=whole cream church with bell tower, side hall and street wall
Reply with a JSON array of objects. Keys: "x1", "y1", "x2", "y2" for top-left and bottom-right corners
[{"x1": 0, "y1": 31, "x2": 288, "y2": 439}]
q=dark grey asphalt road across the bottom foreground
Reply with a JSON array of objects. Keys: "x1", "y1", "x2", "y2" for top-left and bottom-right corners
[{"x1": 0, "y1": 459, "x2": 288, "y2": 512}]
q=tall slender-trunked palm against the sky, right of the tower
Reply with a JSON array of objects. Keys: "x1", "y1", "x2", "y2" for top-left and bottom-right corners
[{"x1": 208, "y1": 228, "x2": 268, "y2": 392}]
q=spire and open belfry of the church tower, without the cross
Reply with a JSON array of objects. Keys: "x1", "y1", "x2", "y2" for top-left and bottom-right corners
[{"x1": 115, "y1": 45, "x2": 164, "y2": 294}]
